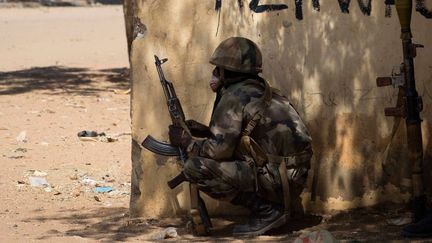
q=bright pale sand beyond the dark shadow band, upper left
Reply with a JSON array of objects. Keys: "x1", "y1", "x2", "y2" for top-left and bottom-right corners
[{"x1": 0, "y1": 6, "x2": 127, "y2": 71}]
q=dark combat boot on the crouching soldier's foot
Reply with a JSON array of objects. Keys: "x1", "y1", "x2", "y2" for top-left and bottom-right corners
[{"x1": 231, "y1": 192, "x2": 286, "y2": 236}]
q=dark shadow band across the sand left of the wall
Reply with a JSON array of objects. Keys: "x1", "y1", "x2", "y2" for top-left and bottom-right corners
[{"x1": 0, "y1": 66, "x2": 130, "y2": 95}]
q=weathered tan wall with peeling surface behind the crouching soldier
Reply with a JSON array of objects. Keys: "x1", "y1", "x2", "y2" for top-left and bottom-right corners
[{"x1": 131, "y1": 0, "x2": 432, "y2": 217}]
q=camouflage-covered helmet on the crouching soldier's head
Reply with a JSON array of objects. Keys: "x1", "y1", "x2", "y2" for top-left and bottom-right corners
[{"x1": 210, "y1": 37, "x2": 262, "y2": 73}]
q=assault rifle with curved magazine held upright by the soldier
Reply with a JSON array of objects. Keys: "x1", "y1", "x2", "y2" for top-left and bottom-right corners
[{"x1": 141, "y1": 55, "x2": 212, "y2": 235}]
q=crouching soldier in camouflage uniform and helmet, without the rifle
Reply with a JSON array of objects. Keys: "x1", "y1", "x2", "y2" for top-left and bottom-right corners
[{"x1": 169, "y1": 37, "x2": 312, "y2": 236}]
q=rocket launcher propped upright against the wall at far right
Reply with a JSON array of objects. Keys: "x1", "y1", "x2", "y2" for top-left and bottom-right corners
[{"x1": 377, "y1": 0, "x2": 426, "y2": 222}]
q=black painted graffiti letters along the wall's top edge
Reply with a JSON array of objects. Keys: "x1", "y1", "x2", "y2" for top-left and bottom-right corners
[{"x1": 215, "y1": 0, "x2": 432, "y2": 20}]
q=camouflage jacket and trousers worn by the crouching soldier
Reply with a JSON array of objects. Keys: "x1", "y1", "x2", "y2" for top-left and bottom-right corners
[{"x1": 184, "y1": 76, "x2": 312, "y2": 203}]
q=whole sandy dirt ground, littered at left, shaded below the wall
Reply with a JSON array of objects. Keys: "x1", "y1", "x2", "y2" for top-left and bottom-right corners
[{"x1": 0, "y1": 6, "x2": 432, "y2": 242}]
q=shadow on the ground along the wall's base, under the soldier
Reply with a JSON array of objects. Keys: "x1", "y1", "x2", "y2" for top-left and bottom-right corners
[{"x1": 24, "y1": 205, "x2": 418, "y2": 242}]
